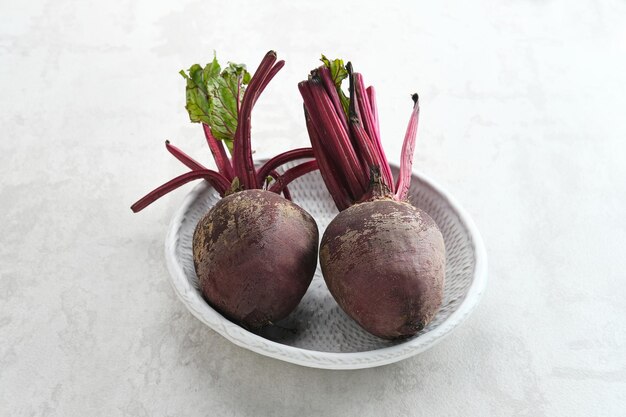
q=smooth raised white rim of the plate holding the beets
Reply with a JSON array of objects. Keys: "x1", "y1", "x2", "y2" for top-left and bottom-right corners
[{"x1": 165, "y1": 171, "x2": 487, "y2": 370}]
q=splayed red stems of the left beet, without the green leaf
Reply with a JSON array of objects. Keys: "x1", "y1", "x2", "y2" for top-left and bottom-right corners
[{"x1": 131, "y1": 51, "x2": 318, "y2": 213}]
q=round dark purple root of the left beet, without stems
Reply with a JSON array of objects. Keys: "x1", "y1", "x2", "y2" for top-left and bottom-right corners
[{"x1": 193, "y1": 190, "x2": 319, "y2": 328}]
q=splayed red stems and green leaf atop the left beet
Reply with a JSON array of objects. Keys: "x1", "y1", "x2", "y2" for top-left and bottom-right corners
[{"x1": 131, "y1": 51, "x2": 317, "y2": 212}]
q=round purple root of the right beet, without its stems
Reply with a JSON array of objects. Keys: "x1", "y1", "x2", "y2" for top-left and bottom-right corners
[{"x1": 320, "y1": 199, "x2": 445, "y2": 339}]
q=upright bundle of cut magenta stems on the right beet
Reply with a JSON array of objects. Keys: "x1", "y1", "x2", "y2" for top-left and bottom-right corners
[{"x1": 298, "y1": 62, "x2": 419, "y2": 211}]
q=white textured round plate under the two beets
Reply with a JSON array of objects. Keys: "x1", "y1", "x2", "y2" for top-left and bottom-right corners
[{"x1": 165, "y1": 167, "x2": 487, "y2": 369}]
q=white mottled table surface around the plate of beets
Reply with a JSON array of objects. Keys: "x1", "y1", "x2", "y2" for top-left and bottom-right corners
[{"x1": 0, "y1": 0, "x2": 626, "y2": 417}]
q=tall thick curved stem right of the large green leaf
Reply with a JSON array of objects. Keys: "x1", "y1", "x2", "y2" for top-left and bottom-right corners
[{"x1": 233, "y1": 51, "x2": 280, "y2": 189}]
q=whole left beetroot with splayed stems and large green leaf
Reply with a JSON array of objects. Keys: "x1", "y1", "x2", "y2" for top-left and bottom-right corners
[{"x1": 131, "y1": 51, "x2": 319, "y2": 328}]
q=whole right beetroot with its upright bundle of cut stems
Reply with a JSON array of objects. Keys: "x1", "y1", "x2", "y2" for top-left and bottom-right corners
[{"x1": 299, "y1": 56, "x2": 445, "y2": 339}]
